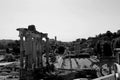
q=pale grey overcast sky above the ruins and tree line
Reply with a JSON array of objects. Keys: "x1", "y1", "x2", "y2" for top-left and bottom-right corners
[{"x1": 0, "y1": 0, "x2": 120, "y2": 41}]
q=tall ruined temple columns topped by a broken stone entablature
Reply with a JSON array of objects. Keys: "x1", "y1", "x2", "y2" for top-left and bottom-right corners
[{"x1": 17, "y1": 28, "x2": 49, "y2": 80}]
